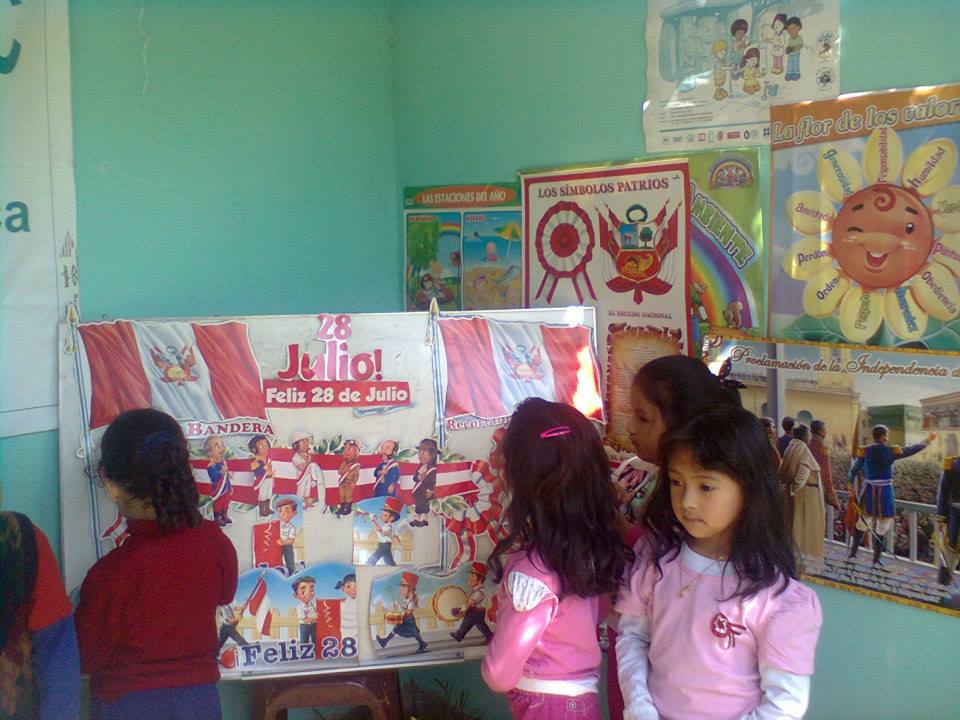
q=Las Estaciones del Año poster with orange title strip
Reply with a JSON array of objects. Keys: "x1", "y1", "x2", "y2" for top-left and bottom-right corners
[{"x1": 403, "y1": 183, "x2": 523, "y2": 310}]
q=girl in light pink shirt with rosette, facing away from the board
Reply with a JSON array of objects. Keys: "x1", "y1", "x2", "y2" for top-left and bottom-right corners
[{"x1": 616, "y1": 406, "x2": 822, "y2": 720}]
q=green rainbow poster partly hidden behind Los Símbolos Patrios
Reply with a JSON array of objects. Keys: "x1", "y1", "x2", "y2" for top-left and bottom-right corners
[{"x1": 688, "y1": 148, "x2": 767, "y2": 347}]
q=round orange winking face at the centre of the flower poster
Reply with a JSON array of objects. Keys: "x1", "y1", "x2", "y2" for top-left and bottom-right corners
[{"x1": 832, "y1": 183, "x2": 933, "y2": 290}]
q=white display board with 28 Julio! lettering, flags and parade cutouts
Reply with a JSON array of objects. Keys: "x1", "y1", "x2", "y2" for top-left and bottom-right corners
[{"x1": 60, "y1": 308, "x2": 602, "y2": 676}]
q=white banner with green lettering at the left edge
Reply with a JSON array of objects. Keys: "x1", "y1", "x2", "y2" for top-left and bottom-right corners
[{"x1": 0, "y1": 0, "x2": 80, "y2": 437}]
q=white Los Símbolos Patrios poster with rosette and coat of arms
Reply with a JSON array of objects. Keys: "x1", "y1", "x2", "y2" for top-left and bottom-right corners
[{"x1": 521, "y1": 160, "x2": 692, "y2": 442}]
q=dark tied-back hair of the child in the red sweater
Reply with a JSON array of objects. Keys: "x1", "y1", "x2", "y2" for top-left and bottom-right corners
[{"x1": 100, "y1": 408, "x2": 202, "y2": 529}]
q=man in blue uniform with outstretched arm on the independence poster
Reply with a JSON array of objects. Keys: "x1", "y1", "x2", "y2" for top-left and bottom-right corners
[{"x1": 847, "y1": 425, "x2": 937, "y2": 571}]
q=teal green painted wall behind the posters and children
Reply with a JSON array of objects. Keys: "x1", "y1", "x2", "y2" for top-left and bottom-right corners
[{"x1": 0, "y1": 0, "x2": 960, "y2": 720}]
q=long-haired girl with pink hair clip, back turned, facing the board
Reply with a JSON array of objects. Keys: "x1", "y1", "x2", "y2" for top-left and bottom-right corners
[{"x1": 482, "y1": 398, "x2": 630, "y2": 720}]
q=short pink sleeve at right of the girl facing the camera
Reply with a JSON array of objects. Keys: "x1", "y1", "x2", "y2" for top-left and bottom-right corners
[{"x1": 757, "y1": 580, "x2": 823, "y2": 675}]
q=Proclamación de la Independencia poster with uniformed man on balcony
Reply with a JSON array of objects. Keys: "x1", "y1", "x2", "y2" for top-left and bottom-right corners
[{"x1": 708, "y1": 339, "x2": 960, "y2": 616}]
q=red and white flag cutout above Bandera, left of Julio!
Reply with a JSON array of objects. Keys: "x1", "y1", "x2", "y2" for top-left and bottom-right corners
[{"x1": 79, "y1": 320, "x2": 266, "y2": 428}]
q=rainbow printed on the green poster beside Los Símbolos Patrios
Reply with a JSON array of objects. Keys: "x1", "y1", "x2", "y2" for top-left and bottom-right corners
[{"x1": 690, "y1": 220, "x2": 759, "y2": 330}]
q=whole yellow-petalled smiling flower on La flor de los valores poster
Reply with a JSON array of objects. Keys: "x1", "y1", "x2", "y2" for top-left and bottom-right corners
[{"x1": 783, "y1": 128, "x2": 960, "y2": 343}]
